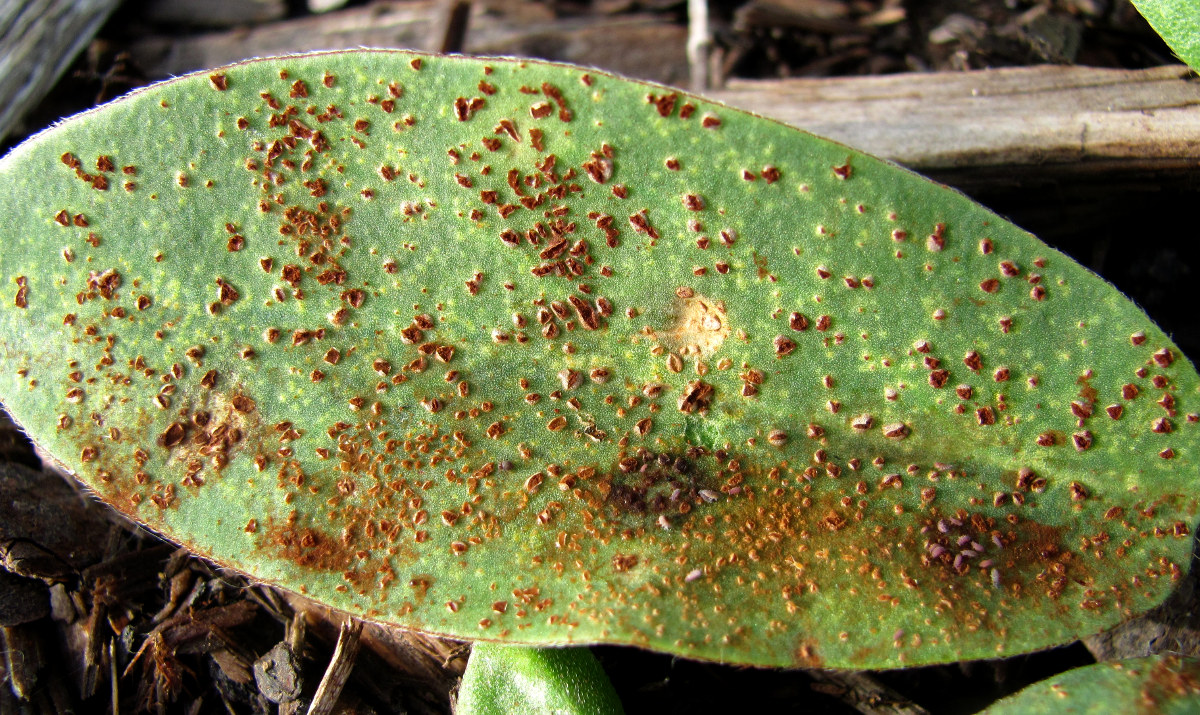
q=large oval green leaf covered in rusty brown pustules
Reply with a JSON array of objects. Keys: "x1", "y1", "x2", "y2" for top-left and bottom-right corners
[{"x1": 0, "y1": 52, "x2": 1200, "y2": 668}]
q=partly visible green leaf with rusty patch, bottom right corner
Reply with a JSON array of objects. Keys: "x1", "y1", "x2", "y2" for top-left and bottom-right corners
[{"x1": 984, "y1": 655, "x2": 1200, "y2": 715}]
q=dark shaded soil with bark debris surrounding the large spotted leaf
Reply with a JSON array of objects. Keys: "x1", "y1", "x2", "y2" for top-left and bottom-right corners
[{"x1": 0, "y1": 0, "x2": 1200, "y2": 715}]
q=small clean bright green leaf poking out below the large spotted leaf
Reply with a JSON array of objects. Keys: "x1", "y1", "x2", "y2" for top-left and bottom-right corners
[{"x1": 455, "y1": 642, "x2": 624, "y2": 715}]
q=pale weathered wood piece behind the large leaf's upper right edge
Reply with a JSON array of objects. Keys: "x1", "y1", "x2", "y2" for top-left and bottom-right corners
[{"x1": 712, "y1": 65, "x2": 1200, "y2": 179}]
